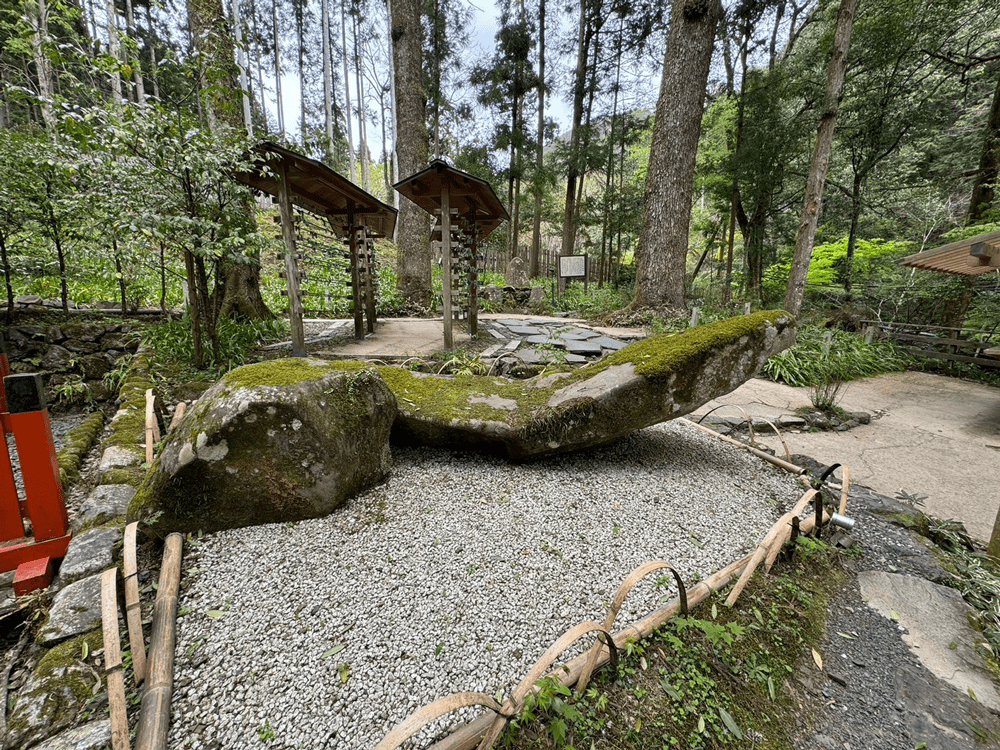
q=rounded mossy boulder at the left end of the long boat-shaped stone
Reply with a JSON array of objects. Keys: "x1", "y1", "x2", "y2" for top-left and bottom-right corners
[{"x1": 128, "y1": 359, "x2": 396, "y2": 534}]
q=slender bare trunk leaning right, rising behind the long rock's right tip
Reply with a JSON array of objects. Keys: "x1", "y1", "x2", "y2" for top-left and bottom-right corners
[{"x1": 785, "y1": 0, "x2": 857, "y2": 317}]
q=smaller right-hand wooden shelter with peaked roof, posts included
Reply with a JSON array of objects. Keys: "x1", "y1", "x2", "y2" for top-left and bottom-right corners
[{"x1": 393, "y1": 159, "x2": 510, "y2": 349}]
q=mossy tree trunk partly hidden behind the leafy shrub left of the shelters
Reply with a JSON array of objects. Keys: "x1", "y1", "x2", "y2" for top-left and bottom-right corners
[{"x1": 187, "y1": 0, "x2": 272, "y2": 320}]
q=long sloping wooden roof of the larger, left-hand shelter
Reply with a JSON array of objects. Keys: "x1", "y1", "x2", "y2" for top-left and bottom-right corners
[{"x1": 234, "y1": 141, "x2": 397, "y2": 237}]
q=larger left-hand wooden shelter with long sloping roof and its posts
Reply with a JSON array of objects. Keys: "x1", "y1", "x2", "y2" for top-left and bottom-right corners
[{"x1": 234, "y1": 141, "x2": 396, "y2": 357}]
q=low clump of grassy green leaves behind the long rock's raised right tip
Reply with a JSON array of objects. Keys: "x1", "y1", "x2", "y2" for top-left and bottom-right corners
[{"x1": 764, "y1": 325, "x2": 913, "y2": 390}]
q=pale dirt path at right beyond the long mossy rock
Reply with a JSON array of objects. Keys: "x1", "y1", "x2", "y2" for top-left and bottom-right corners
[{"x1": 695, "y1": 372, "x2": 1000, "y2": 541}]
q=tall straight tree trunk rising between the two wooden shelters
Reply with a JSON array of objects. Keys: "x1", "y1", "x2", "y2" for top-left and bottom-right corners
[{"x1": 390, "y1": 0, "x2": 431, "y2": 307}]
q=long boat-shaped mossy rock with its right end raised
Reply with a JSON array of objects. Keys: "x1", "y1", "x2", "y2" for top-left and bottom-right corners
[{"x1": 380, "y1": 310, "x2": 795, "y2": 460}]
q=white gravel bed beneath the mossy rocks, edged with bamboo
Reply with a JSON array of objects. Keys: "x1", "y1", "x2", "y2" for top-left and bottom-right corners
[{"x1": 170, "y1": 422, "x2": 801, "y2": 748}]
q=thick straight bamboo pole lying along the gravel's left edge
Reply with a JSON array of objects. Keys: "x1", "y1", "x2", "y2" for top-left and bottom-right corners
[{"x1": 135, "y1": 533, "x2": 184, "y2": 750}]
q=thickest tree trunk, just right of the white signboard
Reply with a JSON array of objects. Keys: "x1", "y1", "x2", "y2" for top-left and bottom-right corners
[{"x1": 631, "y1": 0, "x2": 723, "y2": 309}]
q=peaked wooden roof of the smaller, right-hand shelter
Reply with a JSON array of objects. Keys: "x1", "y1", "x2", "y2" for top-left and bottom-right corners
[{"x1": 393, "y1": 159, "x2": 510, "y2": 241}]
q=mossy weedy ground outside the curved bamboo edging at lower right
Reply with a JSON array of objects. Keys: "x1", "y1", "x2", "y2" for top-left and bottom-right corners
[{"x1": 504, "y1": 537, "x2": 844, "y2": 750}]
